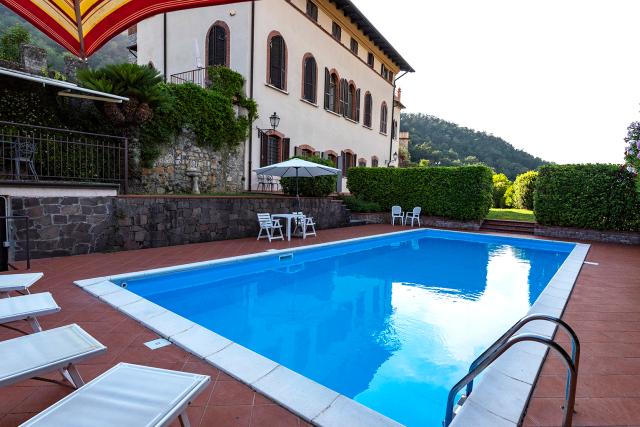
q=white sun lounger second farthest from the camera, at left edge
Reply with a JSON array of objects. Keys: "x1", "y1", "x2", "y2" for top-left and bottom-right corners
[{"x1": 0, "y1": 292, "x2": 60, "y2": 332}]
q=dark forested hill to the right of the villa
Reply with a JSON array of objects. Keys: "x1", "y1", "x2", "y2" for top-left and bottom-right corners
[{"x1": 400, "y1": 114, "x2": 547, "y2": 180}]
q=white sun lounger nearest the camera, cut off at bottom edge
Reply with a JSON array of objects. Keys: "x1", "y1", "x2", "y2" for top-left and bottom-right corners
[{"x1": 22, "y1": 363, "x2": 210, "y2": 427}]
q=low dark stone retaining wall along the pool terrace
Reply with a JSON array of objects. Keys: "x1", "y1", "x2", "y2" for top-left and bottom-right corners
[{"x1": 11, "y1": 196, "x2": 349, "y2": 260}]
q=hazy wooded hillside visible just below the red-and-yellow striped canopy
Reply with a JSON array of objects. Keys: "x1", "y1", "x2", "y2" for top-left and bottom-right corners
[{"x1": 0, "y1": 5, "x2": 129, "y2": 71}]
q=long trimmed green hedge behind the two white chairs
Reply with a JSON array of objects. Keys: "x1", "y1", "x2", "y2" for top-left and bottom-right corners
[{"x1": 347, "y1": 166, "x2": 493, "y2": 220}]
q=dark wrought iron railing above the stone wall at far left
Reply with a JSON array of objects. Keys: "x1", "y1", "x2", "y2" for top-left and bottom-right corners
[{"x1": 0, "y1": 121, "x2": 129, "y2": 192}]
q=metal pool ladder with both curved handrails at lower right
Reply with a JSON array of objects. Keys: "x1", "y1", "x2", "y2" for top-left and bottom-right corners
[{"x1": 442, "y1": 314, "x2": 580, "y2": 427}]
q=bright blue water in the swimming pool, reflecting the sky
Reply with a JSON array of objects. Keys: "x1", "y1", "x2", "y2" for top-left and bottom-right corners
[{"x1": 120, "y1": 230, "x2": 574, "y2": 426}]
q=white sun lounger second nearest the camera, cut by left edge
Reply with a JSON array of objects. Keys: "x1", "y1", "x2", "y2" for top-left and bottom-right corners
[{"x1": 0, "y1": 324, "x2": 107, "y2": 388}]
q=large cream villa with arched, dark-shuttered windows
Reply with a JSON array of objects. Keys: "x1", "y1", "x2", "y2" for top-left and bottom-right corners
[{"x1": 131, "y1": 0, "x2": 413, "y2": 189}]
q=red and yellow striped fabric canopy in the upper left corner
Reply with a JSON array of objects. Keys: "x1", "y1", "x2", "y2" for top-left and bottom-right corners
[{"x1": 0, "y1": 0, "x2": 252, "y2": 59}]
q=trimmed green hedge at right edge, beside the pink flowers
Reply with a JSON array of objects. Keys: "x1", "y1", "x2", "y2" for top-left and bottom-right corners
[{"x1": 534, "y1": 164, "x2": 640, "y2": 231}]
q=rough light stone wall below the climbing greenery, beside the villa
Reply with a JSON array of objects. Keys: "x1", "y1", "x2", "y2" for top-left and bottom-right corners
[{"x1": 134, "y1": 132, "x2": 245, "y2": 195}]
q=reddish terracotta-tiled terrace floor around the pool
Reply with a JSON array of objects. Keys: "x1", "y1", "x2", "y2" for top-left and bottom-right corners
[{"x1": 0, "y1": 225, "x2": 640, "y2": 427}]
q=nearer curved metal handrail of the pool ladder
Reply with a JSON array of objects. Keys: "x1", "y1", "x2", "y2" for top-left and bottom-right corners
[{"x1": 443, "y1": 334, "x2": 578, "y2": 427}]
